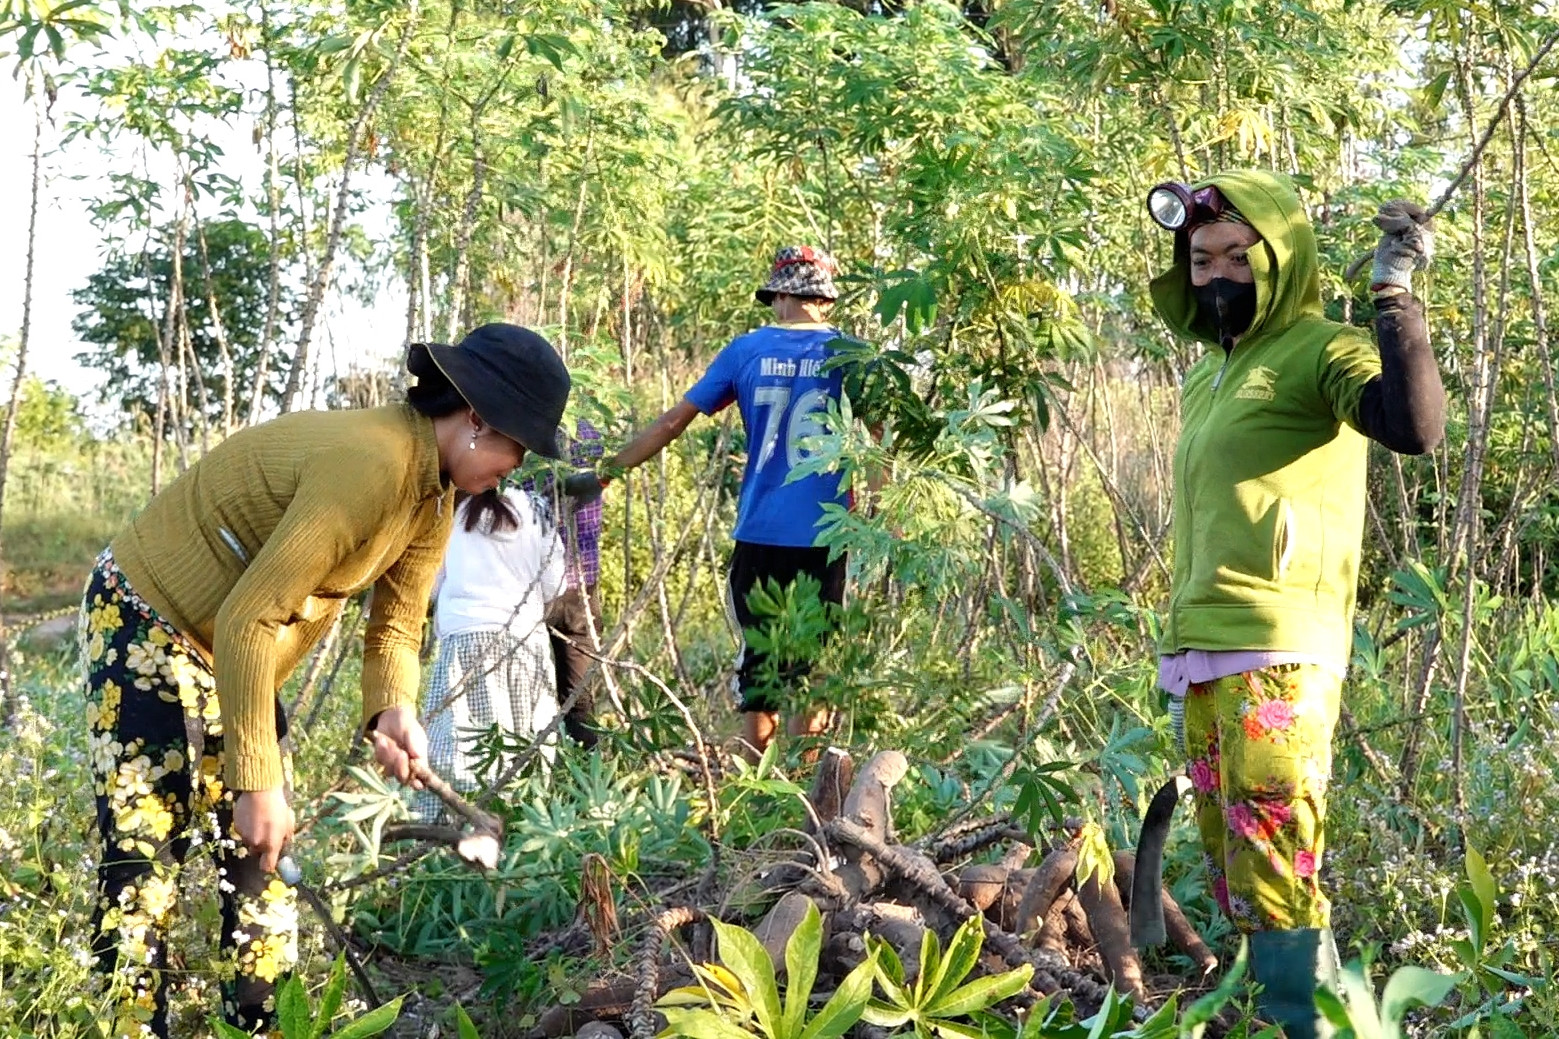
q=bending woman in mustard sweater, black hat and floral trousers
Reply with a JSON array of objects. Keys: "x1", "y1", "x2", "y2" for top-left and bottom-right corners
[{"x1": 81, "y1": 324, "x2": 569, "y2": 1036}]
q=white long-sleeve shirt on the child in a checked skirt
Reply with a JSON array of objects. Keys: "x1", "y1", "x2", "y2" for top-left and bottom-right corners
[{"x1": 433, "y1": 490, "x2": 564, "y2": 638}]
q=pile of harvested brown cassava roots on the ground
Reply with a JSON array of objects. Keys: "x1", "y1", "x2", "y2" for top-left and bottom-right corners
[{"x1": 529, "y1": 749, "x2": 1218, "y2": 1039}]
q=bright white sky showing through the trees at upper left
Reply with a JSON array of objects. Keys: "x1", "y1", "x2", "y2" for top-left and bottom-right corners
[{"x1": 0, "y1": 41, "x2": 405, "y2": 418}]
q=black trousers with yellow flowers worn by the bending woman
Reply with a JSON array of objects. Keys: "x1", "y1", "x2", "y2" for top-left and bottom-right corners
[{"x1": 81, "y1": 552, "x2": 298, "y2": 1037}]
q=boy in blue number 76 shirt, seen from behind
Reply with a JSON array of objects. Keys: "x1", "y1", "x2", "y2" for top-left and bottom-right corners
[{"x1": 575, "y1": 245, "x2": 850, "y2": 755}]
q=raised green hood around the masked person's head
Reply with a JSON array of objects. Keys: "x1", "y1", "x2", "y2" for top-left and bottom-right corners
[{"x1": 1152, "y1": 170, "x2": 1320, "y2": 346}]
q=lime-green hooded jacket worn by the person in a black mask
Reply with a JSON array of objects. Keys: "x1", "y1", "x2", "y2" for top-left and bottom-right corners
[{"x1": 1152, "y1": 172, "x2": 1380, "y2": 658}]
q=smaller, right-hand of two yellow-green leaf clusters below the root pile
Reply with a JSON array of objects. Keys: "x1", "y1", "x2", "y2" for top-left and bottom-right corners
[{"x1": 862, "y1": 914, "x2": 1034, "y2": 1039}]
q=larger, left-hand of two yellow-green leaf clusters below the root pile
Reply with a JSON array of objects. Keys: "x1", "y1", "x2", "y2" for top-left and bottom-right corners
[{"x1": 656, "y1": 903, "x2": 875, "y2": 1039}]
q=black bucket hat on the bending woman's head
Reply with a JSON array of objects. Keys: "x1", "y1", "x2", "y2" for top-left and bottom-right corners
[{"x1": 412, "y1": 321, "x2": 569, "y2": 459}]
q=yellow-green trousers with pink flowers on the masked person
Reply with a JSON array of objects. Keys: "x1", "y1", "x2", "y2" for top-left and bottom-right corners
[{"x1": 1185, "y1": 665, "x2": 1342, "y2": 933}]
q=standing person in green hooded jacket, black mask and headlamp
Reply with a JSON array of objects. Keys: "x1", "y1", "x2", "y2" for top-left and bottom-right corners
[{"x1": 1149, "y1": 172, "x2": 1445, "y2": 1039}]
